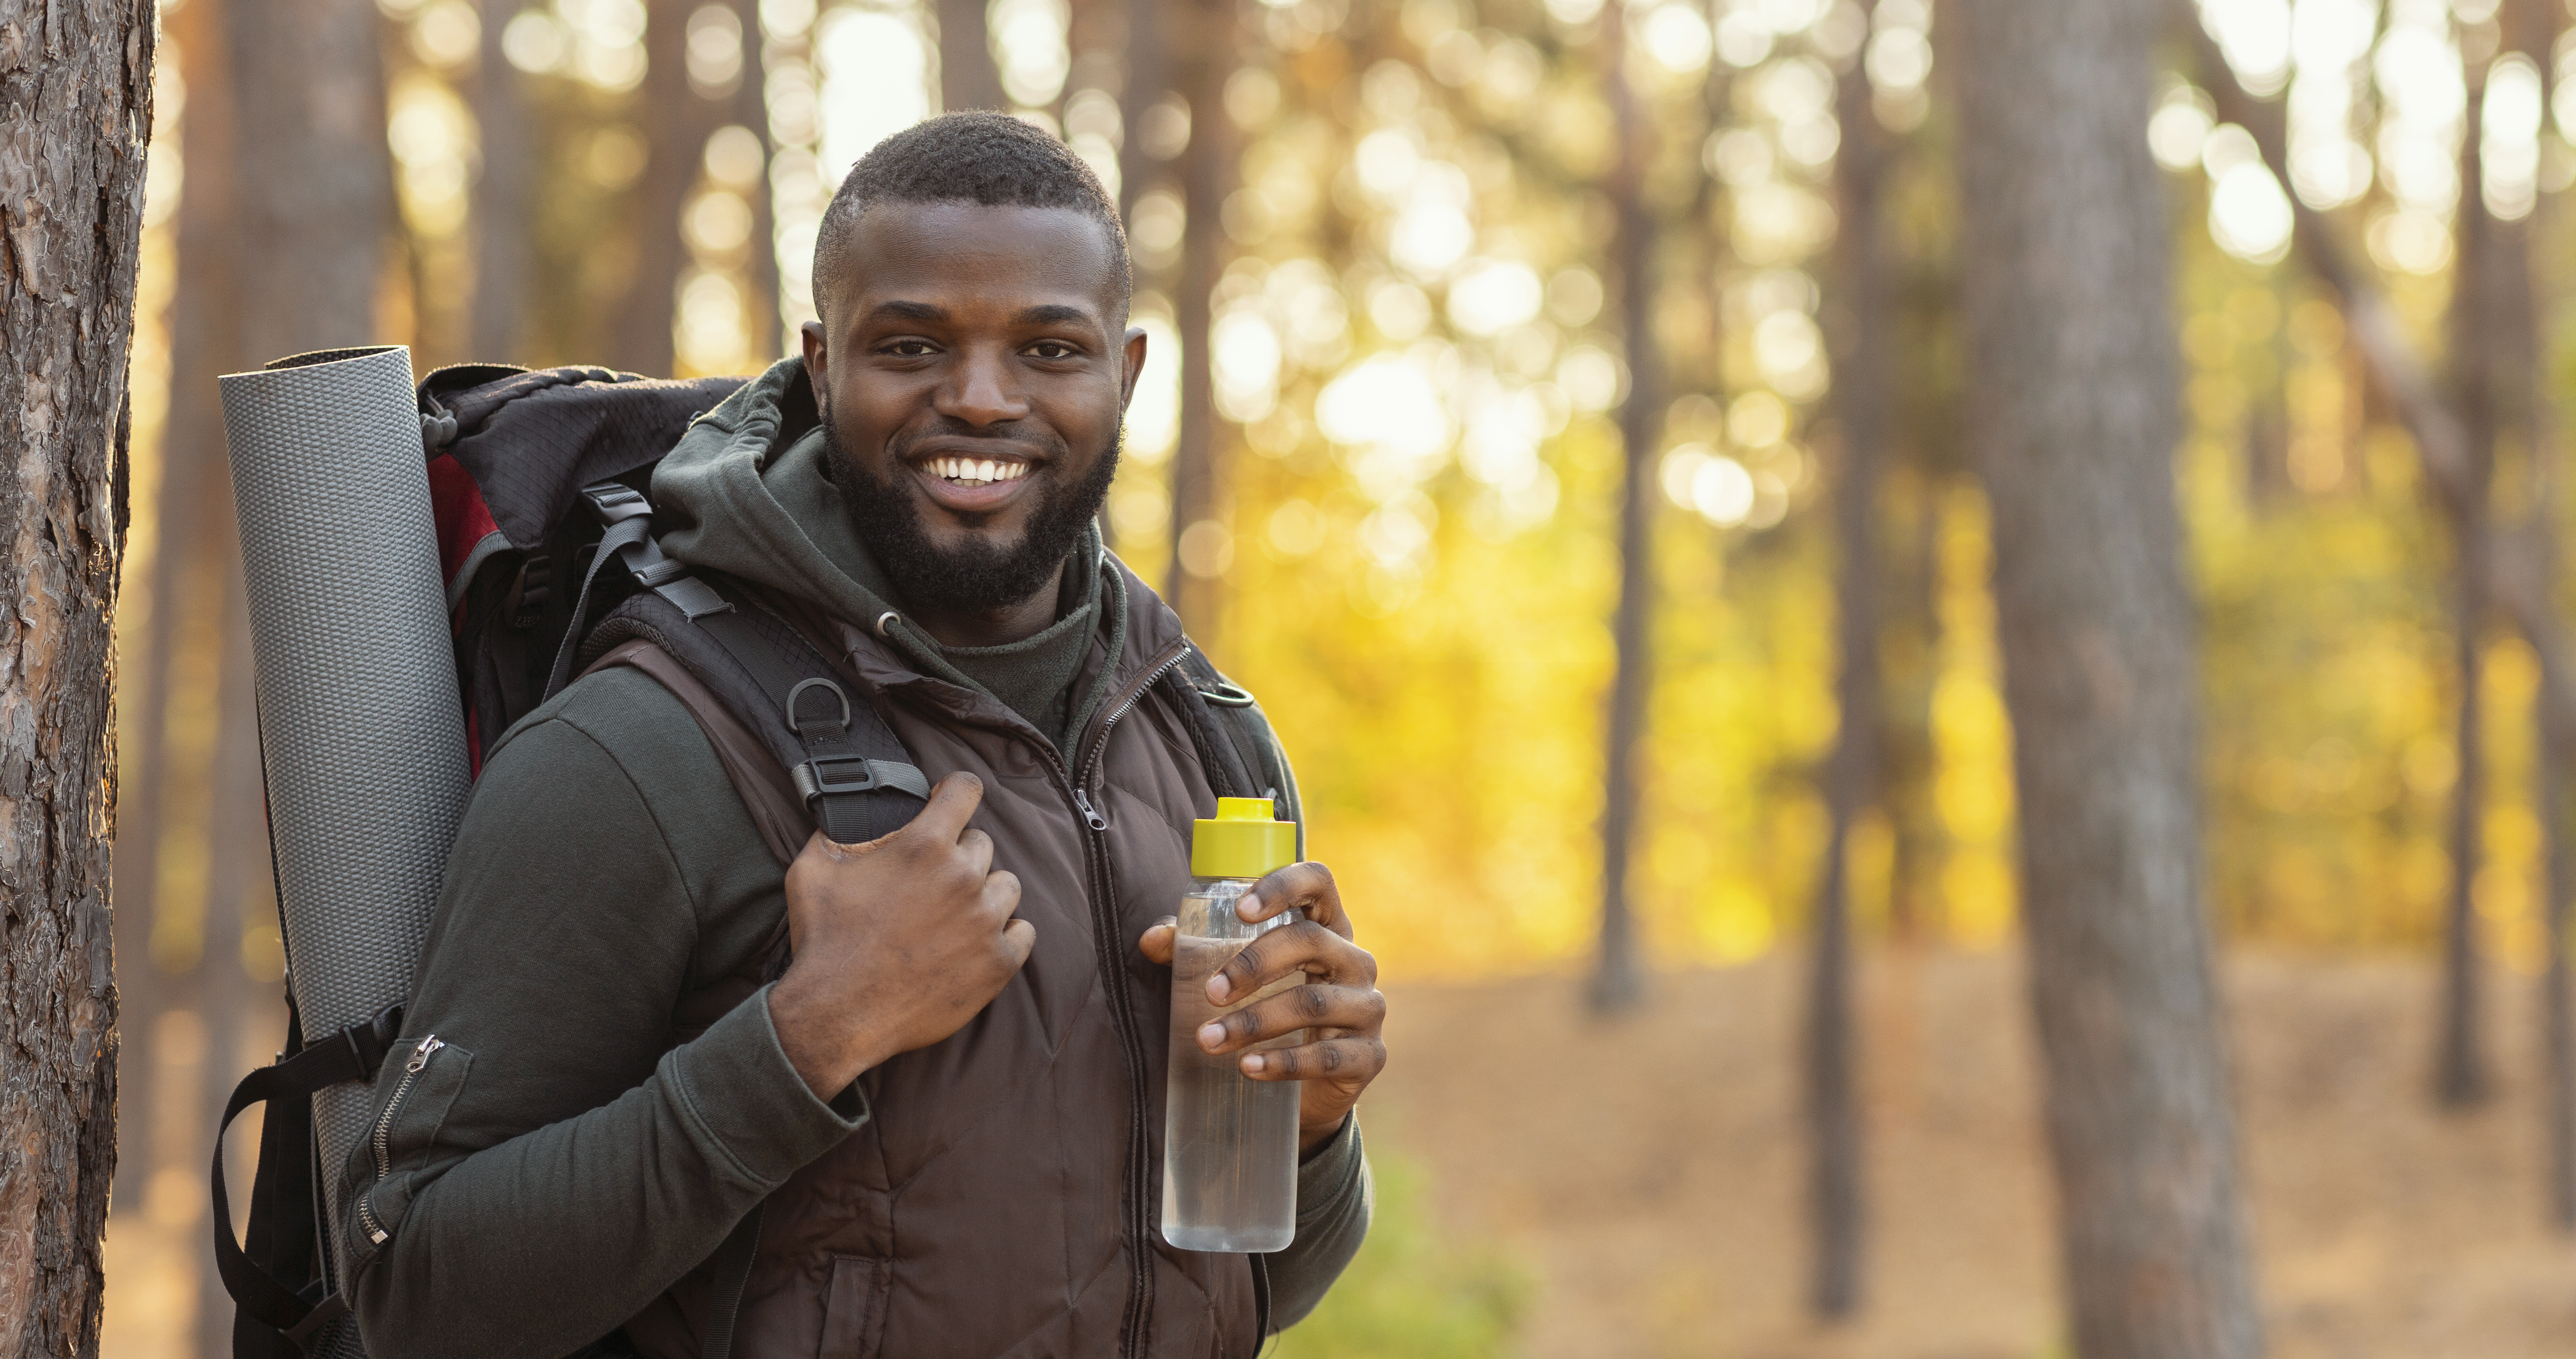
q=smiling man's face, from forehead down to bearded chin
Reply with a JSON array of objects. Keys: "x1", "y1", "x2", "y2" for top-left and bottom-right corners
[{"x1": 804, "y1": 204, "x2": 1144, "y2": 611}]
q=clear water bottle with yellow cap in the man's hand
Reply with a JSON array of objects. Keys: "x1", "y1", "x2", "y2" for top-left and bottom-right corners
[{"x1": 1162, "y1": 797, "x2": 1306, "y2": 1251}]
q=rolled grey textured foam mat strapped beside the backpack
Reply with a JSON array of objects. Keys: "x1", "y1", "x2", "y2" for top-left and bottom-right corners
[{"x1": 222, "y1": 346, "x2": 469, "y2": 1351}]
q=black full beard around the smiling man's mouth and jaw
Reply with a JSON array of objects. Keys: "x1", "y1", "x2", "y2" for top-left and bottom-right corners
[{"x1": 822, "y1": 418, "x2": 1118, "y2": 614}]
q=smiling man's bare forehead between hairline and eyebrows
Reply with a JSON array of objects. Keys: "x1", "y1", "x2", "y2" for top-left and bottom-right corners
[{"x1": 819, "y1": 204, "x2": 1118, "y2": 325}]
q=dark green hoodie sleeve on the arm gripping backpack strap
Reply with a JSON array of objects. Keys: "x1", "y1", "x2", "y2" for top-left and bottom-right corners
[{"x1": 335, "y1": 676, "x2": 865, "y2": 1359}]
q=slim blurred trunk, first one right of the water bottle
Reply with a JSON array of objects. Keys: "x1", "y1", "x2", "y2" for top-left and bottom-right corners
[{"x1": 1589, "y1": 5, "x2": 1664, "y2": 1013}]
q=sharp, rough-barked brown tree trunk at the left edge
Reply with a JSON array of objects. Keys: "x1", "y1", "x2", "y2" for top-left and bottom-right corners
[{"x1": 0, "y1": 0, "x2": 155, "y2": 1357}]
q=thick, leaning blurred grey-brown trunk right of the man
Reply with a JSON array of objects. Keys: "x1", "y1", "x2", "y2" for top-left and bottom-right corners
[{"x1": 1945, "y1": 0, "x2": 2262, "y2": 1359}]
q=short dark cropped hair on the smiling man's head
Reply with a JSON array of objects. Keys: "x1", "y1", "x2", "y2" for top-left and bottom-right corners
[{"x1": 814, "y1": 111, "x2": 1136, "y2": 320}]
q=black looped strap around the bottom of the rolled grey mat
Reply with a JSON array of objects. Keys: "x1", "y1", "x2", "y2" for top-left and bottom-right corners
[{"x1": 211, "y1": 1003, "x2": 402, "y2": 1354}]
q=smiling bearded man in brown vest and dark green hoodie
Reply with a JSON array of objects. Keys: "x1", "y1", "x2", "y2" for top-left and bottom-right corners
[{"x1": 338, "y1": 113, "x2": 1386, "y2": 1359}]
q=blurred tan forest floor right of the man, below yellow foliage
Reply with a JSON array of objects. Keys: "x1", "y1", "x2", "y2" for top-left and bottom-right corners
[{"x1": 1368, "y1": 952, "x2": 2576, "y2": 1359}]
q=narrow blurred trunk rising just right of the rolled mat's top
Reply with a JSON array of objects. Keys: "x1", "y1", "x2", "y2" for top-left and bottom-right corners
[{"x1": 466, "y1": 0, "x2": 536, "y2": 364}]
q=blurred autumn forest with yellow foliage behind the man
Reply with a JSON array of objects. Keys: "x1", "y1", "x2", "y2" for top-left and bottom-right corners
[{"x1": 105, "y1": 0, "x2": 2576, "y2": 1357}]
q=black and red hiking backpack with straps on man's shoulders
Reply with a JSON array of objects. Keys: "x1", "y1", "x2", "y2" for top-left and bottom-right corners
[{"x1": 211, "y1": 364, "x2": 1304, "y2": 1359}]
